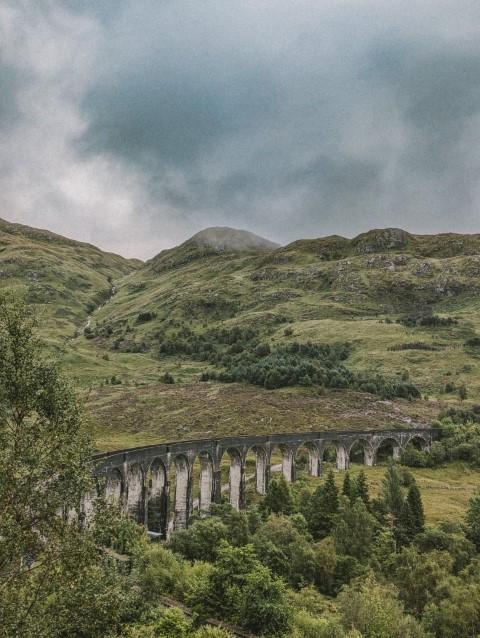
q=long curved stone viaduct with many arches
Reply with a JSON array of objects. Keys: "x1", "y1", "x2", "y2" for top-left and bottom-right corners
[{"x1": 83, "y1": 429, "x2": 437, "y2": 536}]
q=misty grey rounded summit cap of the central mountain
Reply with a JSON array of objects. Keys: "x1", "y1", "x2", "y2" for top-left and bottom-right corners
[{"x1": 186, "y1": 226, "x2": 279, "y2": 252}]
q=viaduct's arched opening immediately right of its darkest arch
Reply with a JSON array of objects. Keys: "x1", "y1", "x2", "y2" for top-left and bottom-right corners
[{"x1": 168, "y1": 454, "x2": 192, "y2": 533}]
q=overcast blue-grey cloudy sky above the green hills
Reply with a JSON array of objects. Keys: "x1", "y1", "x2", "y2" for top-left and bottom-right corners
[{"x1": 0, "y1": 0, "x2": 480, "y2": 258}]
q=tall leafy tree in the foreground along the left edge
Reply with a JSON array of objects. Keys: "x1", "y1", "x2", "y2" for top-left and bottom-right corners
[{"x1": 0, "y1": 295, "x2": 137, "y2": 638}]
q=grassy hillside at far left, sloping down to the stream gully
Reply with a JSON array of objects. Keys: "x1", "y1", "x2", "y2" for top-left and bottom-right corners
[{"x1": 0, "y1": 219, "x2": 141, "y2": 341}]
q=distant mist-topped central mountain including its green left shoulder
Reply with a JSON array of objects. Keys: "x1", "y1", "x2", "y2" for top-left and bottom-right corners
[{"x1": 148, "y1": 226, "x2": 280, "y2": 272}]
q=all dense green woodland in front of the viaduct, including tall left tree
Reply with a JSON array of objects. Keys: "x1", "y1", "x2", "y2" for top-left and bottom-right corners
[{"x1": 4, "y1": 297, "x2": 480, "y2": 638}]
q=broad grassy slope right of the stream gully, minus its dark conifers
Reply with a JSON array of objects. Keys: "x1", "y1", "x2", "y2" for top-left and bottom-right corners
[{"x1": 63, "y1": 229, "x2": 480, "y2": 446}]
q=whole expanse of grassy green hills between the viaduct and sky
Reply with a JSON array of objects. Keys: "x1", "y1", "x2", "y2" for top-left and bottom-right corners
[{"x1": 0, "y1": 222, "x2": 480, "y2": 448}]
